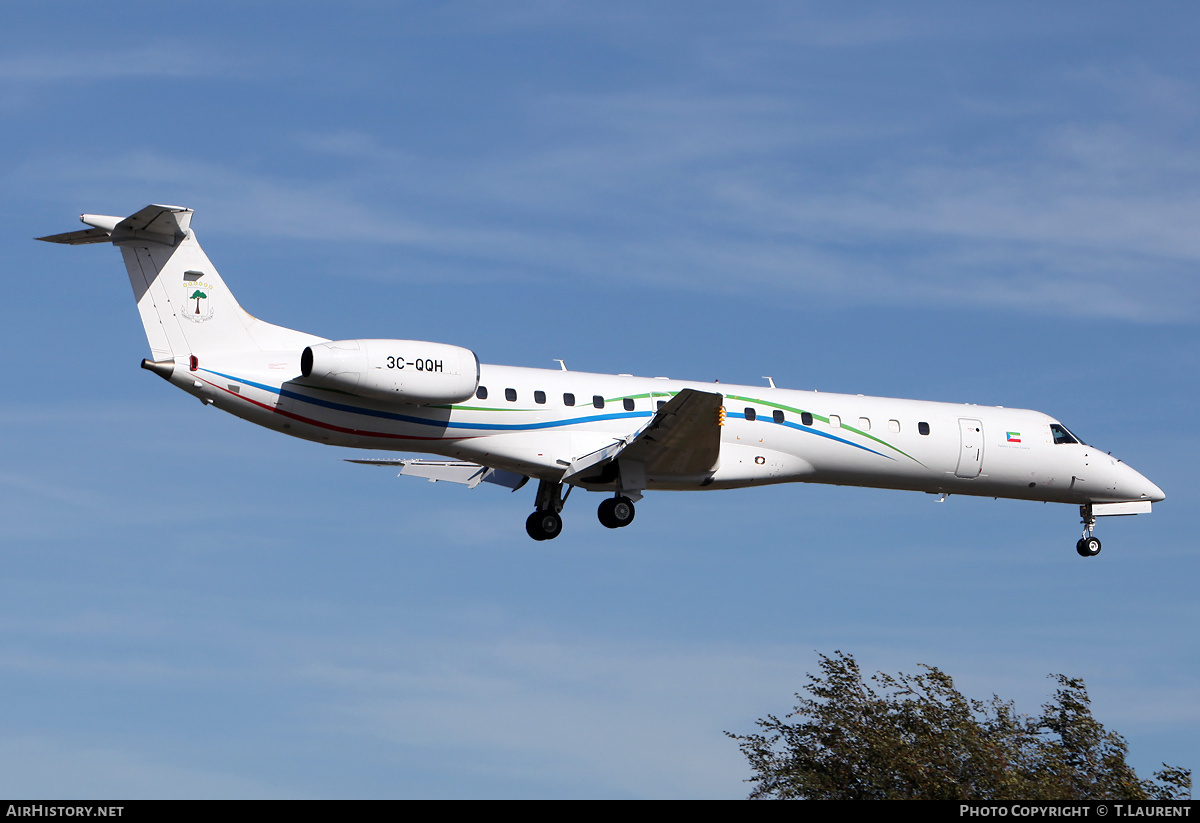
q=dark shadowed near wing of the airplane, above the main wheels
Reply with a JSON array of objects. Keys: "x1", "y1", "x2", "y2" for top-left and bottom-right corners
[{"x1": 563, "y1": 389, "x2": 725, "y2": 488}]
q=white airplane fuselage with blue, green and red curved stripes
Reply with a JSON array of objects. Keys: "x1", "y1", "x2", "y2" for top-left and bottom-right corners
[{"x1": 170, "y1": 350, "x2": 1164, "y2": 504}]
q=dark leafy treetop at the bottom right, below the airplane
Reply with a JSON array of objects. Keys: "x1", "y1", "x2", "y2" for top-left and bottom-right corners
[{"x1": 726, "y1": 651, "x2": 1192, "y2": 801}]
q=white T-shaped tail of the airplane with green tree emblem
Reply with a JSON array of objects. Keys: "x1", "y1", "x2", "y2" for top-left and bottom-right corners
[{"x1": 38, "y1": 205, "x2": 322, "y2": 360}]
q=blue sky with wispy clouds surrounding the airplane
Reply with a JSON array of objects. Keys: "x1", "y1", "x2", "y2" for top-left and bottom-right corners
[{"x1": 0, "y1": 2, "x2": 1200, "y2": 798}]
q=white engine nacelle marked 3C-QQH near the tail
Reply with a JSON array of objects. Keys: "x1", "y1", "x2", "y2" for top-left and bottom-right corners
[{"x1": 300, "y1": 340, "x2": 479, "y2": 406}]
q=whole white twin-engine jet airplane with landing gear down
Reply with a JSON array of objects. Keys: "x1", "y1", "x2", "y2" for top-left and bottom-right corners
[{"x1": 37, "y1": 205, "x2": 1165, "y2": 557}]
